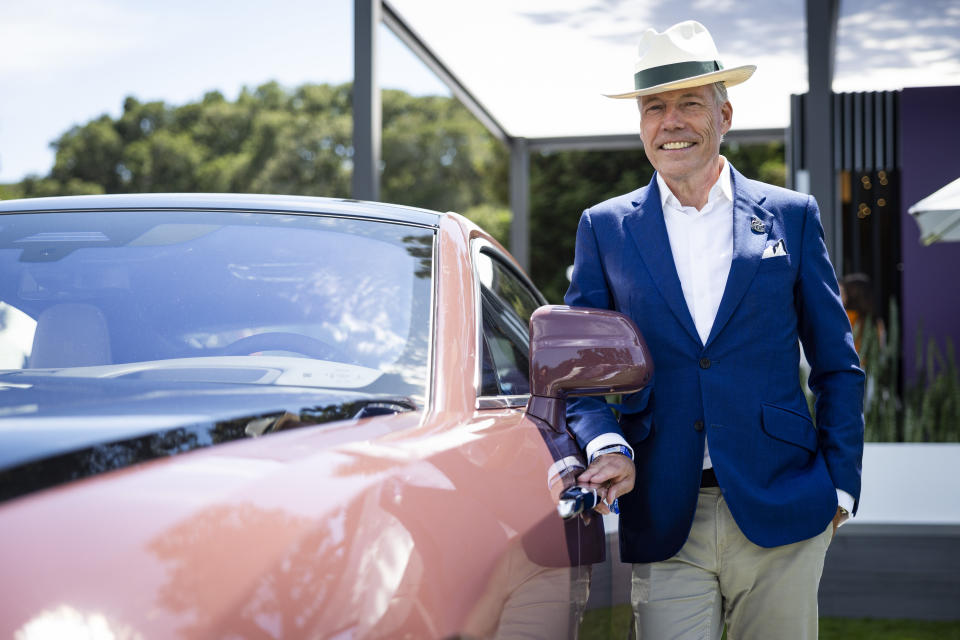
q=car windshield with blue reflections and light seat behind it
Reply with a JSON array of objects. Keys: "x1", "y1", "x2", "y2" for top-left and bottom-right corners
[{"x1": 0, "y1": 211, "x2": 434, "y2": 402}]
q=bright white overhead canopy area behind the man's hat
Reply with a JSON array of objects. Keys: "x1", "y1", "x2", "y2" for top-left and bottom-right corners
[{"x1": 381, "y1": 0, "x2": 960, "y2": 138}]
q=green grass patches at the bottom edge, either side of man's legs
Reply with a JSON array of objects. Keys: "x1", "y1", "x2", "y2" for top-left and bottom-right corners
[{"x1": 580, "y1": 604, "x2": 960, "y2": 640}]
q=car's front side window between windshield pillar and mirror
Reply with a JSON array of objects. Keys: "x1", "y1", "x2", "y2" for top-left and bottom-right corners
[{"x1": 476, "y1": 251, "x2": 541, "y2": 396}]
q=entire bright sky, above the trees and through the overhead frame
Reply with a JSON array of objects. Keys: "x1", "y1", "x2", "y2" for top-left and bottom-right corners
[{"x1": 0, "y1": 0, "x2": 960, "y2": 183}]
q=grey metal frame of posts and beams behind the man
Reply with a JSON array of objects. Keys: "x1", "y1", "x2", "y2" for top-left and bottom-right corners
[{"x1": 353, "y1": 0, "x2": 843, "y2": 271}]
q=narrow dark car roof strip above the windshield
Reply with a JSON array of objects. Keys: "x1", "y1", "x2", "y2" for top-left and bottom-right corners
[{"x1": 0, "y1": 193, "x2": 443, "y2": 227}]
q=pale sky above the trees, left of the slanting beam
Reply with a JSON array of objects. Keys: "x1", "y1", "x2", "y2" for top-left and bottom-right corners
[{"x1": 0, "y1": 0, "x2": 449, "y2": 183}]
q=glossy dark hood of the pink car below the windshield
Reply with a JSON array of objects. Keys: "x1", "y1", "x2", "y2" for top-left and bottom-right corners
[{"x1": 0, "y1": 371, "x2": 416, "y2": 500}]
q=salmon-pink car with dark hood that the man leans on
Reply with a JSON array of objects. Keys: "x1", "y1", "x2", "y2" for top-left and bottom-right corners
[{"x1": 0, "y1": 194, "x2": 651, "y2": 640}]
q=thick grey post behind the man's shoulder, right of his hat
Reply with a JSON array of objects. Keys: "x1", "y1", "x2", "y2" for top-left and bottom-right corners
[{"x1": 803, "y1": 0, "x2": 843, "y2": 273}]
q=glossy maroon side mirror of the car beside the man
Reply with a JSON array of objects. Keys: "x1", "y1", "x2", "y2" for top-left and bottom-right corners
[{"x1": 527, "y1": 305, "x2": 653, "y2": 433}]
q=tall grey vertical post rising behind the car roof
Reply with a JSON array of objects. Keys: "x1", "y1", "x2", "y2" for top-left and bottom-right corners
[{"x1": 351, "y1": 0, "x2": 381, "y2": 200}]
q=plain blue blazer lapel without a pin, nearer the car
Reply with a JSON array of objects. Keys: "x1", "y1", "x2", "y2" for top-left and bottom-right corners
[{"x1": 623, "y1": 178, "x2": 696, "y2": 344}]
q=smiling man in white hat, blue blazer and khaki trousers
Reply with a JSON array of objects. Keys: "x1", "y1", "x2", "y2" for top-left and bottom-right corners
[{"x1": 566, "y1": 22, "x2": 863, "y2": 640}]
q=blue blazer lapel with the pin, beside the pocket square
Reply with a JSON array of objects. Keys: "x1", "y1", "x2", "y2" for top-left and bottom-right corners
[{"x1": 704, "y1": 167, "x2": 774, "y2": 346}]
